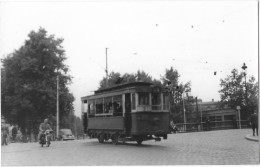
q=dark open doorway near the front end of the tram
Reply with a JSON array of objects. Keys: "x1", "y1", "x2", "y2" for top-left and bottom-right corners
[{"x1": 125, "y1": 93, "x2": 132, "y2": 134}]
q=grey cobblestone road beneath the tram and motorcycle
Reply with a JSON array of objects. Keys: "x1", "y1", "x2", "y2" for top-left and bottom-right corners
[{"x1": 1, "y1": 129, "x2": 259, "y2": 166}]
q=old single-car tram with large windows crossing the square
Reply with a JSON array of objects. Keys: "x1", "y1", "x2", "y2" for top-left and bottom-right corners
[{"x1": 81, "y1": 82, "x2": 169, "y2": 144}]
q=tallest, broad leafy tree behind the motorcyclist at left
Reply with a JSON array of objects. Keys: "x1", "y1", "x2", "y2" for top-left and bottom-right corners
[{"x1": 1, "y1": 28, "x2": 74, "y2": 136}]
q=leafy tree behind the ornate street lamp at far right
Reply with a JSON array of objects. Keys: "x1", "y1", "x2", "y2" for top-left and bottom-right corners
[{"x1": 219, "y1": 69, "x2": 258, "y2": 119}]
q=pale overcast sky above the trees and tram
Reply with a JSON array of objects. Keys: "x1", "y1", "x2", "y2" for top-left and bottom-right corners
[{"x1": 0, "y1": 0, "x2": 258, "y2": 116}]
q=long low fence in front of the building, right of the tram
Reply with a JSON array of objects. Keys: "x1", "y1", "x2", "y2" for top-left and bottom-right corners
[{"x1": 176, "y1": 120, "x2": 249, "y2": 132}]
